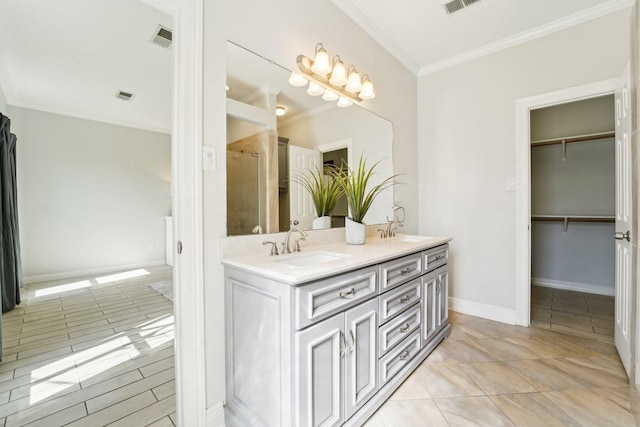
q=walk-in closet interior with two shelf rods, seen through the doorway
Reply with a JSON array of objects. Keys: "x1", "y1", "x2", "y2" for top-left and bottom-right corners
[{"x1": 531, "y1": 95, "x2": 615, "y2": 335}]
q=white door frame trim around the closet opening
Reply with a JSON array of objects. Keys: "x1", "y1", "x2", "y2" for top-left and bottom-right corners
[{"x1": 515, "y1": 78, "x2": 619, "y2": 326}]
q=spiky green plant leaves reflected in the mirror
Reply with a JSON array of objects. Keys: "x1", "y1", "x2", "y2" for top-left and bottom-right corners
[{"x1": 295, "y1": 166, "x2": 344, "y2": 217}]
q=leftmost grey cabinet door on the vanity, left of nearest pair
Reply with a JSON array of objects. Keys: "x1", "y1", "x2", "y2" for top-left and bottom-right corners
[{"x1": 295, "y1": 314, "x2": 346, "y2": 427}]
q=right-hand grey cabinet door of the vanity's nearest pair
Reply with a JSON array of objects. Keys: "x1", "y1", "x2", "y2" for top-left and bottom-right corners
[{"x1": 345, "y1": 299, "x2": 378, "y2": 419}]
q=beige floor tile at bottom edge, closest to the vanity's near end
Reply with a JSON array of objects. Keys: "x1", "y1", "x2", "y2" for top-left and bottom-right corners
[{"x1": 379, "y1": 399, "x2": 448, "y2": 427}]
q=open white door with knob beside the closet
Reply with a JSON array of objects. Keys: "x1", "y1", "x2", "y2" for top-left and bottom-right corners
[{"x1": 615, "y1": 61, "x2": 637, "y2": 374}]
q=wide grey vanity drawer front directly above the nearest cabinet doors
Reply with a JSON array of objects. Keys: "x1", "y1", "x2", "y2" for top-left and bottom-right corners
[{"x1": 295, "y1": 266, "x2": 378, "y2": 329}]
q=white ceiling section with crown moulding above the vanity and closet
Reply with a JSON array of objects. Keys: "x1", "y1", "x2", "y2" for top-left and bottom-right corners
[{"x1": 333, "y1": 0, "x2": 633, "y2": 76}]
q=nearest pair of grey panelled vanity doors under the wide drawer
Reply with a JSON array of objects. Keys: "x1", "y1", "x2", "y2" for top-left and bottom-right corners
[{"x1": 294, "y1": 299, "x2": 378, "y2": 426}]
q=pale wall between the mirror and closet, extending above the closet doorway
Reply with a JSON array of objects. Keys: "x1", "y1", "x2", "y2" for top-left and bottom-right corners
[{"x1": 418, "y1": 11, "x2": 629, "y2": 320}]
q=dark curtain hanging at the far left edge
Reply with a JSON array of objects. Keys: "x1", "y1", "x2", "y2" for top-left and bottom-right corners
[{"x1": 0, "y1": 114, "x2": 22, "y2": 313}]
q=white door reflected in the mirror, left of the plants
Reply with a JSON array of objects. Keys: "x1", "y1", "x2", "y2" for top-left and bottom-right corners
[{"x1": 289, "y1": 144, "x2": 322, "y2": 230}]
